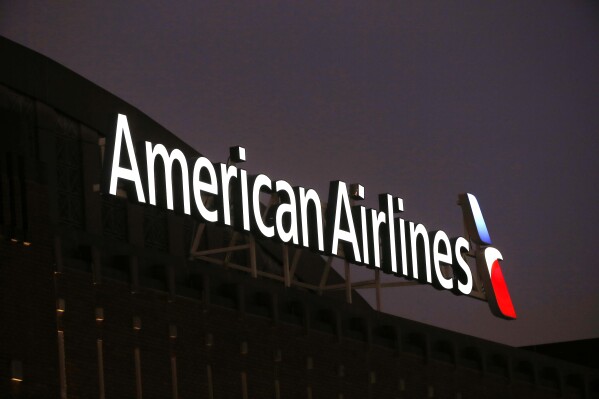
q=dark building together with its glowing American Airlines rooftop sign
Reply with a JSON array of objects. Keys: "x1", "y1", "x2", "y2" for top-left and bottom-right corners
[{"x1": 0, "y1": 38, "x2": 599, "y2": 399}]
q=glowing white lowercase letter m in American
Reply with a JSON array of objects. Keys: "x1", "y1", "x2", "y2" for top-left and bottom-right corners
[{"x1": 146, "y1": 141, "x2": 191, "y2": 215}]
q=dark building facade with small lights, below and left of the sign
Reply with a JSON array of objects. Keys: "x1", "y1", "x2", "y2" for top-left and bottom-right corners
[{"x1": 0, "y1": 38, "x2": 599, "y2": 399}]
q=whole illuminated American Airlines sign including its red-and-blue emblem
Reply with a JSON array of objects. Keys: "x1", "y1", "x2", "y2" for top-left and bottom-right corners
[{"x1": 102, "y1": 114, "x2": 515, "y2": 318}]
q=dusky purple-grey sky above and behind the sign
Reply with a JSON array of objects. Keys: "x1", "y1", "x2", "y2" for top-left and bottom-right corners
[{"x1": 0, "y1": 0, "x2": 599, "y2": 345}]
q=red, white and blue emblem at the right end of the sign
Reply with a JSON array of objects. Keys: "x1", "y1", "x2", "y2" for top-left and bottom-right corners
[{"x1": 459, "y1": 194, "x2": 516, "y2": 319}]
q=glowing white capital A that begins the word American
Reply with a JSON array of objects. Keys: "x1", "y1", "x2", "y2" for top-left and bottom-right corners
[{"x1": 108, "y1": 114, "x2": 146, "y2": 202}]
